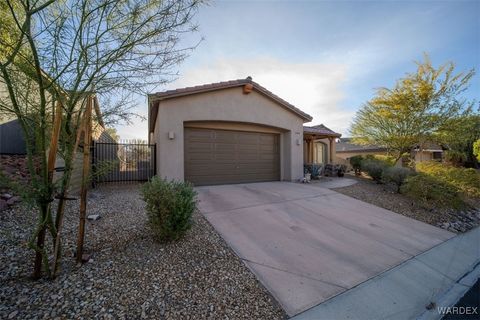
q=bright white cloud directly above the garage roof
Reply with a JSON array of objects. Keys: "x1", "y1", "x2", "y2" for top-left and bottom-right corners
[{"x1": 169, "y1": 58, "x2": 353, "y2": 133}]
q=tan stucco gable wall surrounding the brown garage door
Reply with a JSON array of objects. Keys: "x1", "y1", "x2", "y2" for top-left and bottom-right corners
[{"x1": 152, "y1": 87, "x2": 303, "y2": 181}]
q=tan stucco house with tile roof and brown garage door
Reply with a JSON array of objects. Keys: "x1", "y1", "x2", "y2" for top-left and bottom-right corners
[{"x1": 148, "y1": 77, "x2": 340, "y2": 185}]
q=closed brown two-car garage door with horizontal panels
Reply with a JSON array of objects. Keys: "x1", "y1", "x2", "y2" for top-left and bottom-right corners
[{"x1": 184, "y1": 128, "x2": 280, "y2": 185}]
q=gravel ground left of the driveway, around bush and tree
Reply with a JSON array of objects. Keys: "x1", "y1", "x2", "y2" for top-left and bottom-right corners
[{"x1": 0, "y1": 185, "x2": 286, "y2": 319}]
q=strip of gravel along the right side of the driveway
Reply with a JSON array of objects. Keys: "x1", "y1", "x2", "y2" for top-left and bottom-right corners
[{"x1": 332, "y1": 175, "x2": 480, "y2": 233}]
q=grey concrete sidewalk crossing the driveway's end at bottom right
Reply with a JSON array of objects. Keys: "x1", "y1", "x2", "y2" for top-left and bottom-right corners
[{"x1": 293, "y1": 228, "x2": 480, "y2": 320}]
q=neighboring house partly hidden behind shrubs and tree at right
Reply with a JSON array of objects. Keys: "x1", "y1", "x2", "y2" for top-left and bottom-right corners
[{"x1": 336, "y1": 138, "x2": 444, "y2": 166}]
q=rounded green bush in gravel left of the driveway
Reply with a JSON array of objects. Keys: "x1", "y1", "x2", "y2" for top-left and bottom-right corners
[{"x1": 142, "y1": 177, "x2": 197, "y2": 241}]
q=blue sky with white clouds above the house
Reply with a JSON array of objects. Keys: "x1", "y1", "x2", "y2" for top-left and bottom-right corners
[{"x1": 116, "y1": 0, "x2": 480, "y2": 139}]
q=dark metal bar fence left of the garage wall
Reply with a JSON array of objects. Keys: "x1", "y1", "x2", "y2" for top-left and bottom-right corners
[{"x1": 92, "y1": 142, "x2": 156, "y2": 185}]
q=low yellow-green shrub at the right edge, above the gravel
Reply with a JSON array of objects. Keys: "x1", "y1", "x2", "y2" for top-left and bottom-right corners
[{"x1": 416, "y1": 161, "x2": 480, "y2": 197}]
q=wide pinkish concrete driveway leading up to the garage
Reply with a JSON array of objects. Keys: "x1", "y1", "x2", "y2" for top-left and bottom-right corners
[{"x1": 196, "y1": 182, "x2": 453, "y2": 316}]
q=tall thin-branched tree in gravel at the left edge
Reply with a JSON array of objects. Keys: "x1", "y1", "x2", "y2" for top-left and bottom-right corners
[{"x1": 0, "y1": 0, "x2": 201, "y2": 278}]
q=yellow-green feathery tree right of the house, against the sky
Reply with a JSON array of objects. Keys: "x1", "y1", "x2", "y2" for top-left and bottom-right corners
[{"x1": 350, "y1": 55, "x2": 474, "y2": 160}]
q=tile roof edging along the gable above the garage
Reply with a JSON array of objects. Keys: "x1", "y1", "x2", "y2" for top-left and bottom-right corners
[{"x1": 148, "y1": 77, "x2": 312, "y2": 132}]
